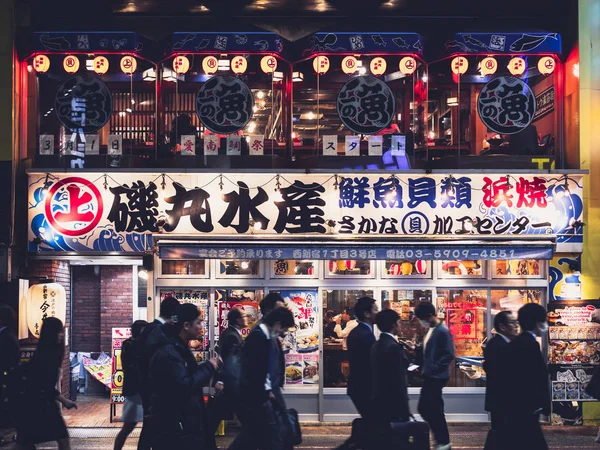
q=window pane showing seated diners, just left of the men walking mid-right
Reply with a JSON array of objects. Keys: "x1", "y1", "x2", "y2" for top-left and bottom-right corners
[{"x1": 323, "y1": 289, "x2": 373, "y2": 387}]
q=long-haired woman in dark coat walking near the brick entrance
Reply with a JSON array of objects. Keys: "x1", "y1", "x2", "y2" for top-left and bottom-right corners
[{"x1": 17, "y1": 317, "x2": 77, "y2": 450}]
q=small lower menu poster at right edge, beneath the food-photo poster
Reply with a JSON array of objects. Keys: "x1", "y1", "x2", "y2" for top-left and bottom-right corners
[{"x1": 549, "y1": 364, "x2": 597, "y2": 402}]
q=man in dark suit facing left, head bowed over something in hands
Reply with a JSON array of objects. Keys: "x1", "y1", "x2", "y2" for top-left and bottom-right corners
[{"x1": 415, "y1": 302, "x2": 454, "y2": 450}]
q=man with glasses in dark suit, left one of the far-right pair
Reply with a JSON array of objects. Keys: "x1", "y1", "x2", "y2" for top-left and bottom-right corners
[{"x1": 483, "y1": 311, "x2": 519, "y2": 430}]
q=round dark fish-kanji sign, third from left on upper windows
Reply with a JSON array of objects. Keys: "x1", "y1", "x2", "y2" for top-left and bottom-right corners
[{"x1": 337, "y1": 76, "x2": 396, "y2": 134}]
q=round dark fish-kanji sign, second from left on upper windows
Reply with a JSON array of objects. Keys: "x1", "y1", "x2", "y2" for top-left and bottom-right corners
[{"x1": 196, "y1": 76, "x2": 254, "y2": 134}]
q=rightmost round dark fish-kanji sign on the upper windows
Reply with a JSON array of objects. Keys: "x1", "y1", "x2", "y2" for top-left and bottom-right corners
[{"x1": 477, "y1": 76, "x2": 536, "y2": 134}]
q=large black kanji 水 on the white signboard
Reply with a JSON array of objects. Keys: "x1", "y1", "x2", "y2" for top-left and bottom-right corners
[{"x1": 219, "y1": 181, "x2": 269, "y2": 233}]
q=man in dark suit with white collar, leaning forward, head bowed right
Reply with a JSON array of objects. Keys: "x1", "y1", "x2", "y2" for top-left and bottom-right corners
[{"x1": 229, "y1": 308, "x2": 295, "y2": 450}]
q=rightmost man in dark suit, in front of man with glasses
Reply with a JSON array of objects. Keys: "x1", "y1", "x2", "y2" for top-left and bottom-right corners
[{"x1": 504, "y1": 303, "x2": 550, "y2": 450}]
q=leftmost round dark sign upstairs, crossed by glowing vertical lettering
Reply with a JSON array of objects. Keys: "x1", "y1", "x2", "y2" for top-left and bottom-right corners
[{"x1": 54, "y1": 75, "x2": 112, "y2": 133}]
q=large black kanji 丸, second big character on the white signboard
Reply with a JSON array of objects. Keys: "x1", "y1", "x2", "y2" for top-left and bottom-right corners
[{"x1": 165, "y1": 183, "x2": 214, "y2": 233}]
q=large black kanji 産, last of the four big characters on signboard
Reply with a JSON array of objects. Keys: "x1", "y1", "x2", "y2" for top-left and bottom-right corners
[{"x1": 273, "y1": 181, "x2": 326, "y2": 233}]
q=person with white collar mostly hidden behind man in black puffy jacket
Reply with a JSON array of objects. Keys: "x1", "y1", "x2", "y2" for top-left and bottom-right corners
[{"x1": 137, "y1": 297, "x2": 179, "y2": 450}]
